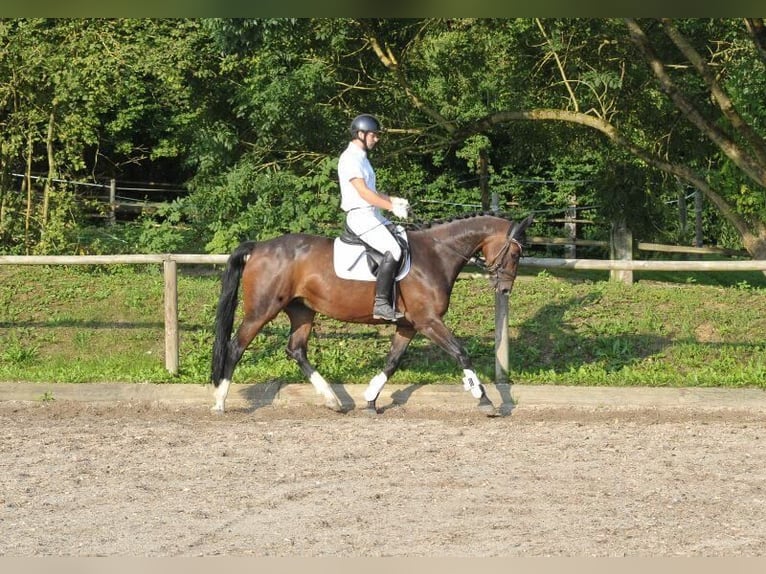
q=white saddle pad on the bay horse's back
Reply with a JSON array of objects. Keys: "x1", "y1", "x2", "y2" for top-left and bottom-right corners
[{"x1": 333, "y1": 223, "x2": 411, "y2": 281}]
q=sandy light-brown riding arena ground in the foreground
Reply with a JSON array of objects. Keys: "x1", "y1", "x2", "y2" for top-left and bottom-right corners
[{"x1": 0, "y1": 401, "x2": 766, "y2": 557}]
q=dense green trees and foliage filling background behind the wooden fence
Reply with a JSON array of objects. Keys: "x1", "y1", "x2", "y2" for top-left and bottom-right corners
[{"x1": 0, "y1": 18, "x2": 766, "y2": 260}]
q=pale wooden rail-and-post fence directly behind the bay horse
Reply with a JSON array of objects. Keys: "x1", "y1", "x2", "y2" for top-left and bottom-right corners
[{"x1": 0, "y1": 254, "x2": 766, "y2": 383}]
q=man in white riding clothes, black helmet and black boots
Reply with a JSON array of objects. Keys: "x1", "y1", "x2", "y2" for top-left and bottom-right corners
[{"x1": 338, "y1": 114, "x2": 410, "y2": 321}]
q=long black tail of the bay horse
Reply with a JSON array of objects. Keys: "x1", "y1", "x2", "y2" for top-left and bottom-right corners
[{"x1": 210, "y1": 241, "x2": 255, "y2": 387}]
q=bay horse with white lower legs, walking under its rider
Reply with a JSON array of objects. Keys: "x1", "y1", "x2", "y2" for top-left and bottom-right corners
[{"x1": 211, "y1": 214, "x2": 532, "y2": 416}]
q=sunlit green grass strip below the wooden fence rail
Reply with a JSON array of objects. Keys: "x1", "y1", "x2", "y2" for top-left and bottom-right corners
[{"x1": 0, "y1": 266, "x2": 766, "y2": 388}]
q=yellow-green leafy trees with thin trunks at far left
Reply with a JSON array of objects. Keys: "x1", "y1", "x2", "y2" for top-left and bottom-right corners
[{"x1": 0, "y1": 19, "x2": 209, "y2": 252}]
